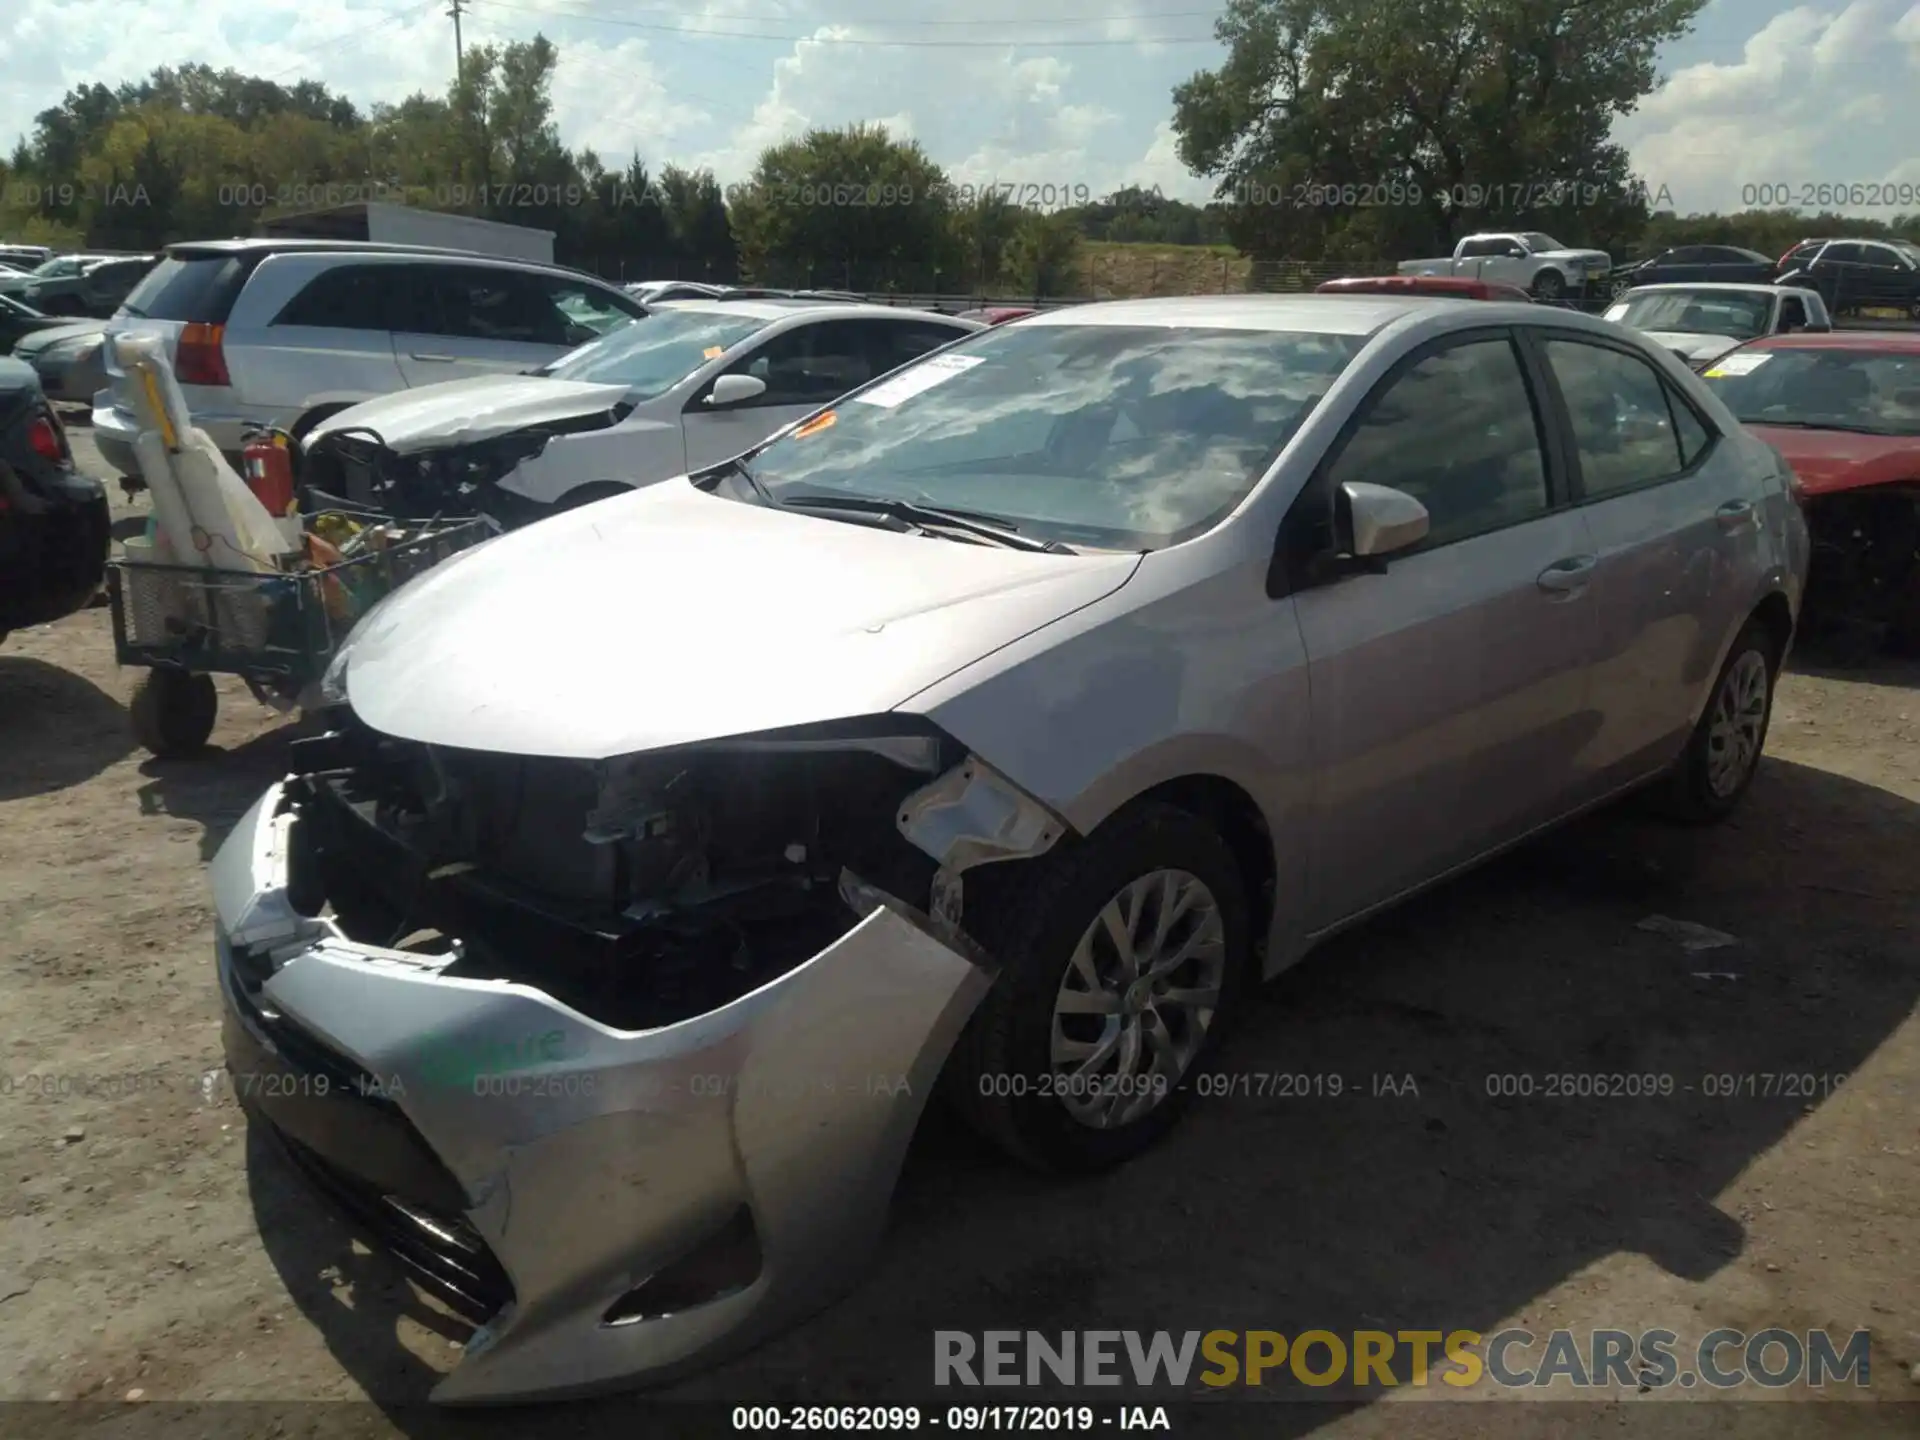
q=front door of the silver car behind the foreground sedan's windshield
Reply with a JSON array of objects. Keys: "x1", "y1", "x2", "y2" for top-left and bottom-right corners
[{"x1": 684, "y1": 321, "x2": 887, "y2": 470}]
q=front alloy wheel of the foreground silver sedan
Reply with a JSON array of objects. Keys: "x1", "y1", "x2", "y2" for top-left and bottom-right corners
[{"x1": 1050, "y1": 870, "x2": 1227, "y2": 1129}]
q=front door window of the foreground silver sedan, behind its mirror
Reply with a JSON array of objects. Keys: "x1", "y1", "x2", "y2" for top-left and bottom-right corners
[{"x1": 1329, "y1": 336, "x2": 1549, "y2": 549}]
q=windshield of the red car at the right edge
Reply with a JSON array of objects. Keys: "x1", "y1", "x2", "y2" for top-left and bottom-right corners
[{"x1": 1705, "y1": 348, "x2": 1920, "y2": 436}]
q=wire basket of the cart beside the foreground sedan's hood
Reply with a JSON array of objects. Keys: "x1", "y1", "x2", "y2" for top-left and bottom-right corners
[{"x1": 108, "y1": 505, "x2": 497, "y2": 685}]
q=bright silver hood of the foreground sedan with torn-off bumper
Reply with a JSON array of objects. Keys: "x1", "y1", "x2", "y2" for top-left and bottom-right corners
[{"x1": 342, "y1": 478, "x2": 1140, "y2": 758}]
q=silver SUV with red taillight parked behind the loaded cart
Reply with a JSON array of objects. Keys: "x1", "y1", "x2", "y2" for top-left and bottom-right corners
[{"x1": 94, "y1": 240, "x2": 647, "y2": 474}]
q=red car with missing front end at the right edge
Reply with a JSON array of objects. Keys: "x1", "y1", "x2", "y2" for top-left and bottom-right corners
[{"x1": 1705, "y1": 330, "x2": 1920, "y2": 653}]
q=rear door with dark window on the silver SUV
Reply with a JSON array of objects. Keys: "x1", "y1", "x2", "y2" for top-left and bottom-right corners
[{"x1": 394, "y1": 261, "x2": 582, "y2": 386}]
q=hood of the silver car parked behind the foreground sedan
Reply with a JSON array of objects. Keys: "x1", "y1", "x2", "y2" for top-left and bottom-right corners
[{"x1": 307, "y1": 374, "x2": 626, "y2": 455}]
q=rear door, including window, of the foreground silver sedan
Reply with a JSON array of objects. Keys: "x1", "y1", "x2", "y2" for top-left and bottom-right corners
[{"x1": 1528, "y1": 330, "x2": 1761, "y2": 789}]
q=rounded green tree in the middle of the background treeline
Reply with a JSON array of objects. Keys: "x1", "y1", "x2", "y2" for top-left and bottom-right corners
[{"x1": 733, "y1": 125, "x2": 962, "y2": 290}]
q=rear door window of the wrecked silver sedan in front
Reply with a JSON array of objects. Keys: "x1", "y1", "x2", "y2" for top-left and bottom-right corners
[{"x1": 1544, "y1": 340, "x2": 1686, "y2": 499}]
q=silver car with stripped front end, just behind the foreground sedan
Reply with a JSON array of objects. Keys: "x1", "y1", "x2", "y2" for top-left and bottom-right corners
[{"x1": 301, "y1": 300, "x2": 985, "y2": 524}]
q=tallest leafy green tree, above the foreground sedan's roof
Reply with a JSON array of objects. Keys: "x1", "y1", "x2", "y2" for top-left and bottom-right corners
[{"x1": 1173, "y1": 0, "x2": 1705, "y2": 257}]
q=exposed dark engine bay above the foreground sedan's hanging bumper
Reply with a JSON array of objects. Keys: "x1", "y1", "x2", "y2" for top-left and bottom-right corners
[{"x1": 276, "y1": 714, "x2": 960, "y2": 1029}]
